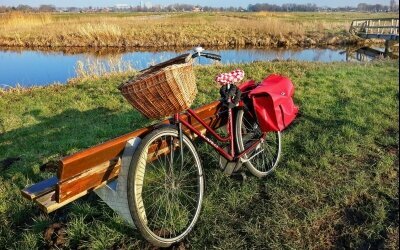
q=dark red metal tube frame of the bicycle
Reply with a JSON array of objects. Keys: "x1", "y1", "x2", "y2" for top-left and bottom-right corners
[{"x1": 174, "y1": 102, "x2": 265, "y2": 161}]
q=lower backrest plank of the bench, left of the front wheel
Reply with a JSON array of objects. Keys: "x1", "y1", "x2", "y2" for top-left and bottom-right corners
[{"x1": 56, "y1": 158, "x2": 121, "y2": 202}]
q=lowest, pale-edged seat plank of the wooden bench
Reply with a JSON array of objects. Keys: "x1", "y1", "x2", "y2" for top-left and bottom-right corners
[{"x1": 35, "y1": 181, "x2": 107, "y2": 213}]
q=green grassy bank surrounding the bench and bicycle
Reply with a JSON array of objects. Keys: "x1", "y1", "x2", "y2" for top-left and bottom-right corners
[{"x1": 0, "y1": 61, "x2": 399, "y2": 249}]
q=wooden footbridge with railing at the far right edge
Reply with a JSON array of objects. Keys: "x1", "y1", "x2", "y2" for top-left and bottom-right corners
[{"x1": 349, "y1": 18, "x2": 399, "y2": 41}]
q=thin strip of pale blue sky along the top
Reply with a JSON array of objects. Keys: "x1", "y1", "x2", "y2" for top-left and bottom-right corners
[{"x1": 0, "y1": 0, "x2": 390, "y2": 8}]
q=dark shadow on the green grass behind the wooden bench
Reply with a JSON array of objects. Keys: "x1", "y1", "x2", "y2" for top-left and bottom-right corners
[{"x1": 0, "y1": 107, "x2": 149, "y2": 181}]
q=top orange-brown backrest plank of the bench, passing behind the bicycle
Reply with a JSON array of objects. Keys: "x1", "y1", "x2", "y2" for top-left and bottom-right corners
[{"x1": 57, "y1": 101, "x2": 221, "y2": 182}]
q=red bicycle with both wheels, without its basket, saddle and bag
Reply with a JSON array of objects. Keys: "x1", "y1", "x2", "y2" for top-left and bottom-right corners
[{"x1": 128, "y1": 47, "x2": 281, "y2": 247}]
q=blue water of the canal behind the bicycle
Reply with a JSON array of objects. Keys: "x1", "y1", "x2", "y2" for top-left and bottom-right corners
[{"x1": 0, "y1": 48, "x2": 376, "y2": 88}]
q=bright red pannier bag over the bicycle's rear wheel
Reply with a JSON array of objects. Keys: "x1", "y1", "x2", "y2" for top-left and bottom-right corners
[{"x1": 249, "y1": 74, "x2": 299, "y2": 132}]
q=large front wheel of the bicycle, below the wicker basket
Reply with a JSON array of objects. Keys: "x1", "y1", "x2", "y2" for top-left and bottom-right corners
[{"x1": 128, "y1": 127, "x2": 204, "y2": 247}]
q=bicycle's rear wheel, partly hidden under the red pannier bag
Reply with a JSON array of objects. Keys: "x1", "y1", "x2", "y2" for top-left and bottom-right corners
[{"x1": 235, "y1": 108, "x2": 281, "y2": 178}]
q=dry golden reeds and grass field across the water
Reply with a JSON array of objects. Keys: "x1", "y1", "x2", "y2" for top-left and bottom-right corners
[{"x1": 0, "y1": 12, "x2": 396, "y2": 47}]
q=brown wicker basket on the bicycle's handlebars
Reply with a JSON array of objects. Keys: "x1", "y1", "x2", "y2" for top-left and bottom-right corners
[{"x1": 119, "y1": 54, "x2": 197, "y2": 118}]
